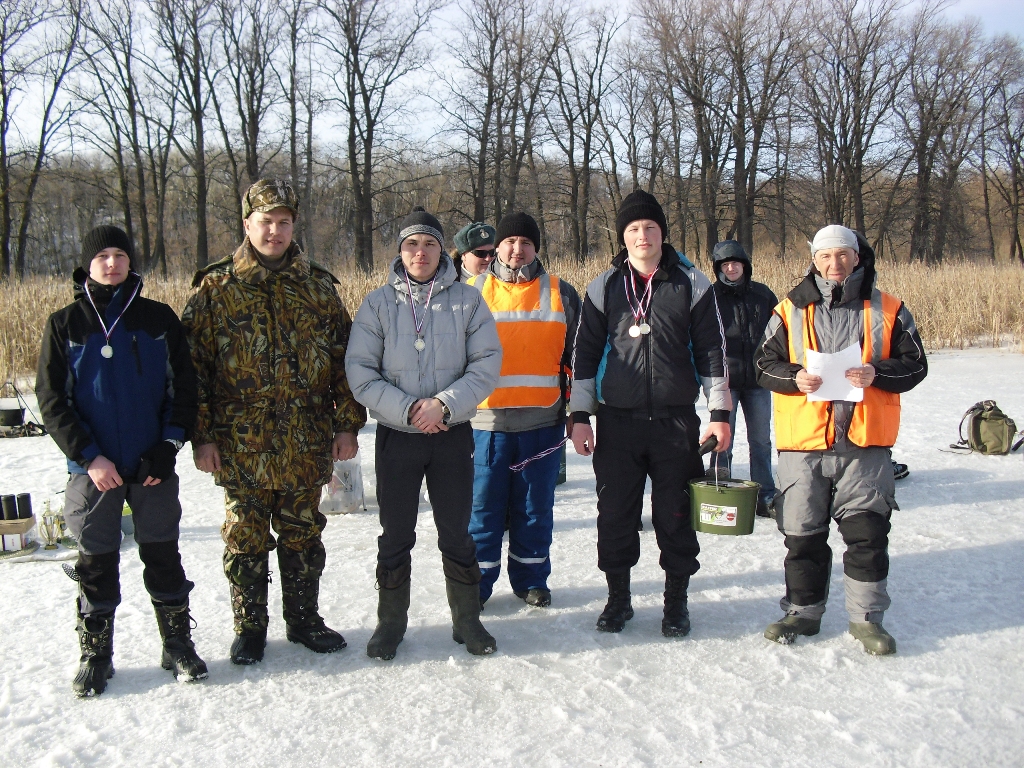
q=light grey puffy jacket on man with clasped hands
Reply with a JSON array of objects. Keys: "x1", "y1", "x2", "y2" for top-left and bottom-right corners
[{"x1": 345, "y1": 254, "x2": 502, "y2": 432}]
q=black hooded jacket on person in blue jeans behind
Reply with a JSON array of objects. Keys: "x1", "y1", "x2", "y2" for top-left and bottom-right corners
[{"x1": 715, "y1": 258, "x2": 778, "y2": 389}]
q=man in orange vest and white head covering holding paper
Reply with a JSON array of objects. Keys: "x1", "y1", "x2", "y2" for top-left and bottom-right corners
[{"x1": 755, "y1": 224, "x2": 928, "y2": 655}]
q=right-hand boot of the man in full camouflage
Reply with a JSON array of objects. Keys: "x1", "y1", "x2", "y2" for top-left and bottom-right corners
[{"x1": 278, "y1": 545, "x2": 348, "y2": 653}]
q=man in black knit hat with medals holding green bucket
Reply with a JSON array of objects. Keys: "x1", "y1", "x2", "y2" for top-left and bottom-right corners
[{"x1": 569, "y1": 190, "x2": 731, "y2": 637}]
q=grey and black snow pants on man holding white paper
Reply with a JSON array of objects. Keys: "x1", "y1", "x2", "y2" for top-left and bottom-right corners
[{"x1": 775, "y1": 443, "x2": 899, "y2": 622}]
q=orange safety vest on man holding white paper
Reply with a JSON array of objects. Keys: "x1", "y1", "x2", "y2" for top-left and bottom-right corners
[{"x1": 772, "y1": 289, "x2": 902, "y2": 451}]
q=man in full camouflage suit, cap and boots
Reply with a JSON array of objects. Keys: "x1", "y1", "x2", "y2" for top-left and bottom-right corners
[{"x1": 182, "y1": 180, "x2": 367, "y2": 664}]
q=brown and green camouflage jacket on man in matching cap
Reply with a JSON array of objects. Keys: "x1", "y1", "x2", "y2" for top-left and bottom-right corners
[{"x1": 181, "y1": 239, "x2": 367, "y2": 490}]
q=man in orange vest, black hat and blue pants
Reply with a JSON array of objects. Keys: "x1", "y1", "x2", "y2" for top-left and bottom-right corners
[{"x1": 468, "y1": 213, "x2": 580, "y2": 607}]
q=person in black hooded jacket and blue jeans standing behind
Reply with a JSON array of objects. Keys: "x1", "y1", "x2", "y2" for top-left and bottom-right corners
[{"x1": 712, "y1": 240, "x2": 778, "y2": 517}]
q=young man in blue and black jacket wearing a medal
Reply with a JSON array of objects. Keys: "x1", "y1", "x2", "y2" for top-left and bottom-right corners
[{"x1": 36, "y1": 225, "x2": 207, "y2": 696}]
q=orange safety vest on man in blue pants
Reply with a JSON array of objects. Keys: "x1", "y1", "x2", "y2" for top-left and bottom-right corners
[{"x1": 467, "y1": 272, "x2": 566, "y2": 409}]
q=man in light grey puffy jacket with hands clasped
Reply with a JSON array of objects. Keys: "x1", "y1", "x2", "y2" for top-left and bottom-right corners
[{"x1": 345, "y1": 208, "x2": 502, "y2": 660}]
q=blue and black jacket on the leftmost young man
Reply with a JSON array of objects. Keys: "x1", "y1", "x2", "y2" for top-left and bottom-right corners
[{"x1": 36, "y1": 269, "x2": 198, "y2": 479}]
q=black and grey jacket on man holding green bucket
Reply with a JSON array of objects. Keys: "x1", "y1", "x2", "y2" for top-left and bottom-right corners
[{"x1": 569, "y1": 245, "x2": 731, "y2": 423}]
